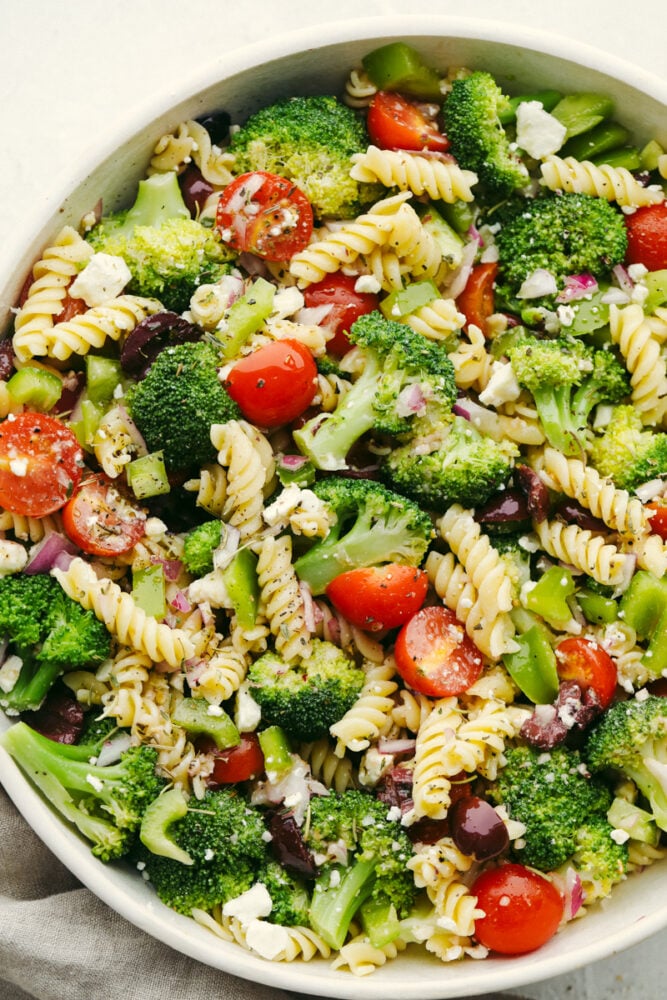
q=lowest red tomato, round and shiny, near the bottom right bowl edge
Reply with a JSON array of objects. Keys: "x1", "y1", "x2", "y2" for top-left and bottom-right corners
[{"x1": 470, "y1": 864, "x2": 564, "y2": 955}]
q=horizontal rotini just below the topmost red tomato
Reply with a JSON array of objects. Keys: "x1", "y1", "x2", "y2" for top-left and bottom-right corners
[{"x1": 350, "y1": 146, "x2": 477, "y2": 204}]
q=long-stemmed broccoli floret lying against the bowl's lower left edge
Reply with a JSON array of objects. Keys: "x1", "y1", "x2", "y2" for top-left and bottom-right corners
[{"x1": 0, "y1": 722, "x2": 164, "y2": 861}]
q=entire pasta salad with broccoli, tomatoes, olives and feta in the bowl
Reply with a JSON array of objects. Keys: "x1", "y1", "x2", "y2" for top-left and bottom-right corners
[{"x1": 0, "y1": 42, "x2": 667, "y2": 975}]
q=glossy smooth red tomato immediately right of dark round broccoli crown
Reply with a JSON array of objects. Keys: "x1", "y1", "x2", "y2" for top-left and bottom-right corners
[{"x1": 225, "y1": 340, "x2": 317, "y2": 427}]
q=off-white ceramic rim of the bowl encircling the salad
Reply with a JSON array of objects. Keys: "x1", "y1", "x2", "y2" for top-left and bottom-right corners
[{"x1": 0, "y1": 14, "x2": 667, "y2": 1000}]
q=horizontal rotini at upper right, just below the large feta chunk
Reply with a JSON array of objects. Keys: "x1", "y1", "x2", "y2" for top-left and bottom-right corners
[{"x1": 540, "y1": 156, "x2": 664, "y2": 208}]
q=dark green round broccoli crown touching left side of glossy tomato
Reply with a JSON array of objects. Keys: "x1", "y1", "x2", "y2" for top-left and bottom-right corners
[{"x1": 127, "y1": 341, "x2": 240, "y2": 472}]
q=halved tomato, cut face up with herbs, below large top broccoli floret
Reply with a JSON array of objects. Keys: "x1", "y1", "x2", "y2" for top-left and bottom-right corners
[{"x1": 215, "y1": 170, "x2": 313, "y2": 260}]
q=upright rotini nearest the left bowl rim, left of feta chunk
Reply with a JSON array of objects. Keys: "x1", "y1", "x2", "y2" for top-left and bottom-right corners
[{"x1": 13, "y1": 226, "x2": 93, "y2": 361}]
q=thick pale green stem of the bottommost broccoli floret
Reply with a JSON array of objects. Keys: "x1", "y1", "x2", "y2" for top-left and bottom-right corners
[{"x1": 310, "y1": 860, "x2": 377, "y2": 951}]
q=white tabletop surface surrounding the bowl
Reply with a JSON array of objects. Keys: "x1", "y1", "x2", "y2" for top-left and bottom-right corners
[{"x1": 0, "y1": 0, "x2": 667, "y2": 1000}]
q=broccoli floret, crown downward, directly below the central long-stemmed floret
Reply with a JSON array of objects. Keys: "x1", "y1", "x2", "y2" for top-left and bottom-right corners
[{"x1": 382, "y1": 416, "x2": 518, "y2": 512}]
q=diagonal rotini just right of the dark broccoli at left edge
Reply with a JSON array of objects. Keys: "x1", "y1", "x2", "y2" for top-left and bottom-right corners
[{"x1": 52, "y1": 557, "x2": 194, "y2": 667}]
